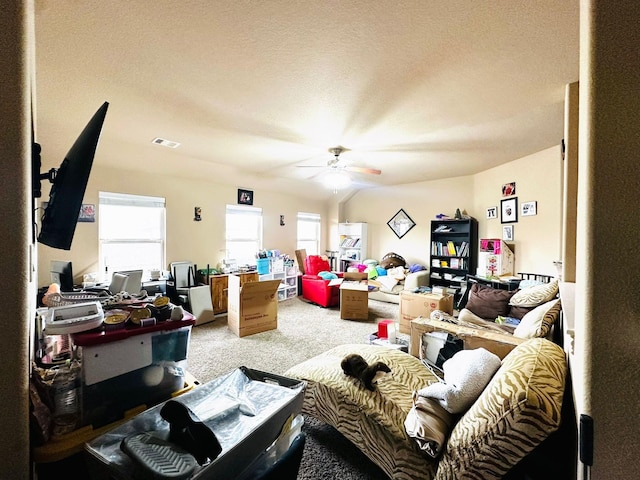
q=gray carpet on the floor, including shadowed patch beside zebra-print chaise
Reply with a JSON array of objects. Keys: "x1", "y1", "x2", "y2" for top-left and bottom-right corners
[{"x1": 188, "y1": 297, "x2": 398, "y2": 480}]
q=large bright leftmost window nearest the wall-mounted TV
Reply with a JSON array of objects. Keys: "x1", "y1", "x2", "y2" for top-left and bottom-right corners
[{"x1": 98, "y1": 192, "x2": 166, "y2": 280}]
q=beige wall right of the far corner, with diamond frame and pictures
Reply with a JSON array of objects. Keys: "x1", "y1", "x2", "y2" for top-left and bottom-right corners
[{"x1": 341, "y1": 145, "x2": 562, "y2": 275}]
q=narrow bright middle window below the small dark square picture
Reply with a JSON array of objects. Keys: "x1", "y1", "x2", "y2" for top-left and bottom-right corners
[{"x1": 225, "y1": 205, "x2": 262, "y2": 265}]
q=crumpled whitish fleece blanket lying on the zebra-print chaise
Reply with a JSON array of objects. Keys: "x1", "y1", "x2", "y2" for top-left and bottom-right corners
[{"x1": 418, "y1": 348, "x2": 502, "y2": 413}]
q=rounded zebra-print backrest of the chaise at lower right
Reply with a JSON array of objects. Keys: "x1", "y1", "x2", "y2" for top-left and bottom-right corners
[{"x1": 435, "y1": 338, "x2": 567, "y2": 480}]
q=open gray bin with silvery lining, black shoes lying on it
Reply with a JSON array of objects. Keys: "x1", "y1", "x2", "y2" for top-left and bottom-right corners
[{"x1": 85, "y1": 367, "x2": 306, "y2": 480}]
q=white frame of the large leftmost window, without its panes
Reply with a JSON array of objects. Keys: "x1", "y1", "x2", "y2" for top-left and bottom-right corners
[{"x1": 98, "y1": 192, "x2": 167, "y2": 281}]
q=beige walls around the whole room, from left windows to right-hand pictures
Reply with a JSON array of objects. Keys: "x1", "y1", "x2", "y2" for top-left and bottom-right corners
[{"x1": 38, "y1": 147, "x2": 562, "y2": 286}]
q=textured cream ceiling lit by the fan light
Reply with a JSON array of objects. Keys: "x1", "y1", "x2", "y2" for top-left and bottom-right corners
[{"x1": 36, "y1": 0, "x2": 579, "y2": 198}]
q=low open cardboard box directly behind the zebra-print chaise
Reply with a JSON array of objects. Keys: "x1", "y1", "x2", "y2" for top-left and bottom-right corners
[{"x1": 409, "y1": 317, "x2": 526, "y2": 358}]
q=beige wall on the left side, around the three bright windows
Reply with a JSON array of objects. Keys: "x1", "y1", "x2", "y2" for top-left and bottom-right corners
[{"x1": 38, "y1": 163, "x2": 327, "y2": 286}]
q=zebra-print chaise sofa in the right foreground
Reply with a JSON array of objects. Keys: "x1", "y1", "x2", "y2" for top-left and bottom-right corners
[{"x1": 285, "y1": 338, "x2": 567, "y2": 480}]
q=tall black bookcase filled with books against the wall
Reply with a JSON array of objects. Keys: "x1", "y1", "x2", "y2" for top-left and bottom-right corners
[{"x1": 429, "y1": 218, "x2": 478, "y2": 302}]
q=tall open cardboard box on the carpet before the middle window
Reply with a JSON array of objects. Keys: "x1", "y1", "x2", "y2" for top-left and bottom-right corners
[{"x1": 227, "y1": 275, "x2": 280, "y2": 337}]
